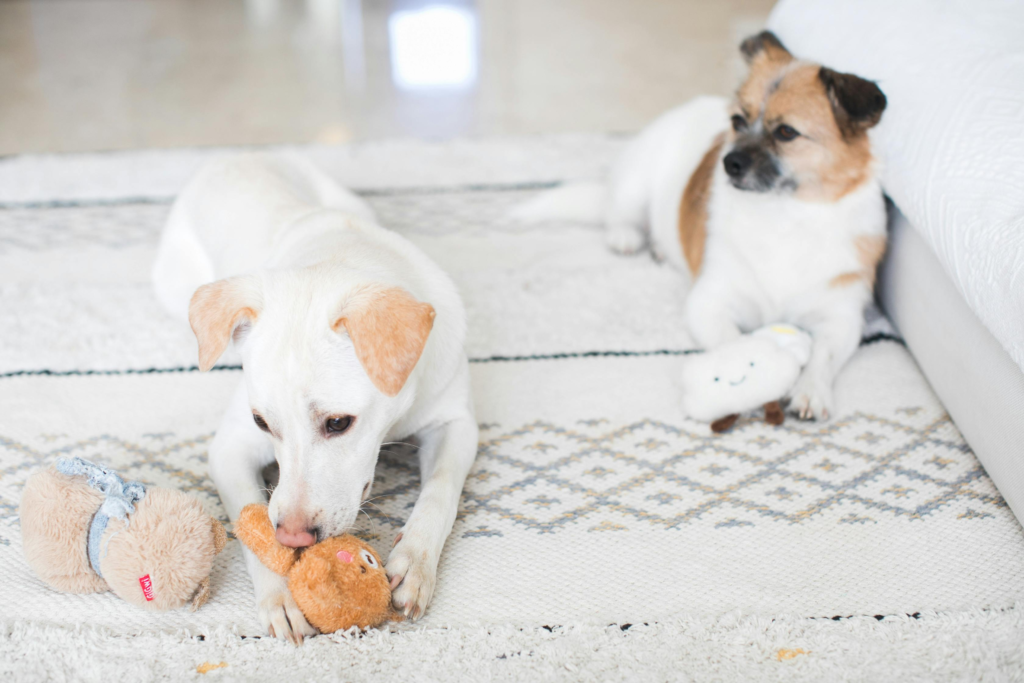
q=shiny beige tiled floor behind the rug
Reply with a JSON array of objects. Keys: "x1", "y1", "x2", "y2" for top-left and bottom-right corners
[{"x1": 0, "y1": 0, "x2": 772, "y2": 154}]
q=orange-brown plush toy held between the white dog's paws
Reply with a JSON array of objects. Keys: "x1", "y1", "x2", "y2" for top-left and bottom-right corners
[{"x1": 234, "y1": 504, "x2": 401, "y2": 633}]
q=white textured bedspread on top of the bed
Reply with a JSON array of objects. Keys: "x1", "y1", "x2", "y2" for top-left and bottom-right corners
[{"x1": 768, "y1": 0, "x2": 1024, "y2": 369}]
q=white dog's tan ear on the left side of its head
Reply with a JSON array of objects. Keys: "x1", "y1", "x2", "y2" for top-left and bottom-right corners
[{"x1": 188, "y1": 275, "x2": 262, "y2": 372}]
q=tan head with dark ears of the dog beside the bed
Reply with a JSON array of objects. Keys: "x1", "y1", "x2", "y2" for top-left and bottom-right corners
[{"x1": 729, "y1": 32, "x2": 886, "y2": 202}]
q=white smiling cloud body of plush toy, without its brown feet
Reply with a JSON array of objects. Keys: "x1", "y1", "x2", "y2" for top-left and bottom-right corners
[{"x1": 683, "y1": 336, "x2": 800, "y2": 422}]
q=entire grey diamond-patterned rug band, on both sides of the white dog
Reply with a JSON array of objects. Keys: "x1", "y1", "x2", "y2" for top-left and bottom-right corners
[{"x1": 0, "y1": 413, "x2": 1007, "y2": 543}]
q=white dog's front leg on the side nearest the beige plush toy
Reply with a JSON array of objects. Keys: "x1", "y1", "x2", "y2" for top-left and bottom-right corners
[{"x1": 210, "y1": 383, "x2": 316, "y2": 645}]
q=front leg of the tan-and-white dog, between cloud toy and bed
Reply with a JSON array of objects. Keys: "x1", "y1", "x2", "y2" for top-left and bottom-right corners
[{"x1": 790, "y1": 301, "x2": 864, "y2": 420}]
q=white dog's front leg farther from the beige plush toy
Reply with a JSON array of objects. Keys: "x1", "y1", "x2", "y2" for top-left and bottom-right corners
[{"x1": 386, "y1": 415, "x2": 477, "y2": 620}]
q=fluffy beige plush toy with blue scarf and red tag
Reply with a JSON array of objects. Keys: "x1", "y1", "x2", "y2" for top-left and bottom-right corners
[{"x1": 18, "y1": 458, "x2": 227, "y2": 610}]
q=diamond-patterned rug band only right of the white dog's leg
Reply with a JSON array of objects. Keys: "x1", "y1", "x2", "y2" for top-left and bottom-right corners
[{"x1": 460, "y1": 413, "x2": 1006, "y2": 533}]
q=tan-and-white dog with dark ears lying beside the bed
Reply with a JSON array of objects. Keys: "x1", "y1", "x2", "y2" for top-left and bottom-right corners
[{"x1": 516, "y1": 32, "x2": 886, "y2": 419}]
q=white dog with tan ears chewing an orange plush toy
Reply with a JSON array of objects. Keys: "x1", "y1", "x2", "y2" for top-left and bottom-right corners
[{"x1": 154, "y1": 155, "x2": 477, "y2": 643}]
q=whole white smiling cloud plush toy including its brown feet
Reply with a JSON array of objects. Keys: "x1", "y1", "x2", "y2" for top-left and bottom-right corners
[{"x1": 683, "y1": 325, "x2": 811, "y2": 432}]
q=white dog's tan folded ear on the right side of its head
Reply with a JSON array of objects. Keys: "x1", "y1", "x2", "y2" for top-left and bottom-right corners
[{"x1": 331, "y1": 286, "x2": 434, "y2": 396}]
